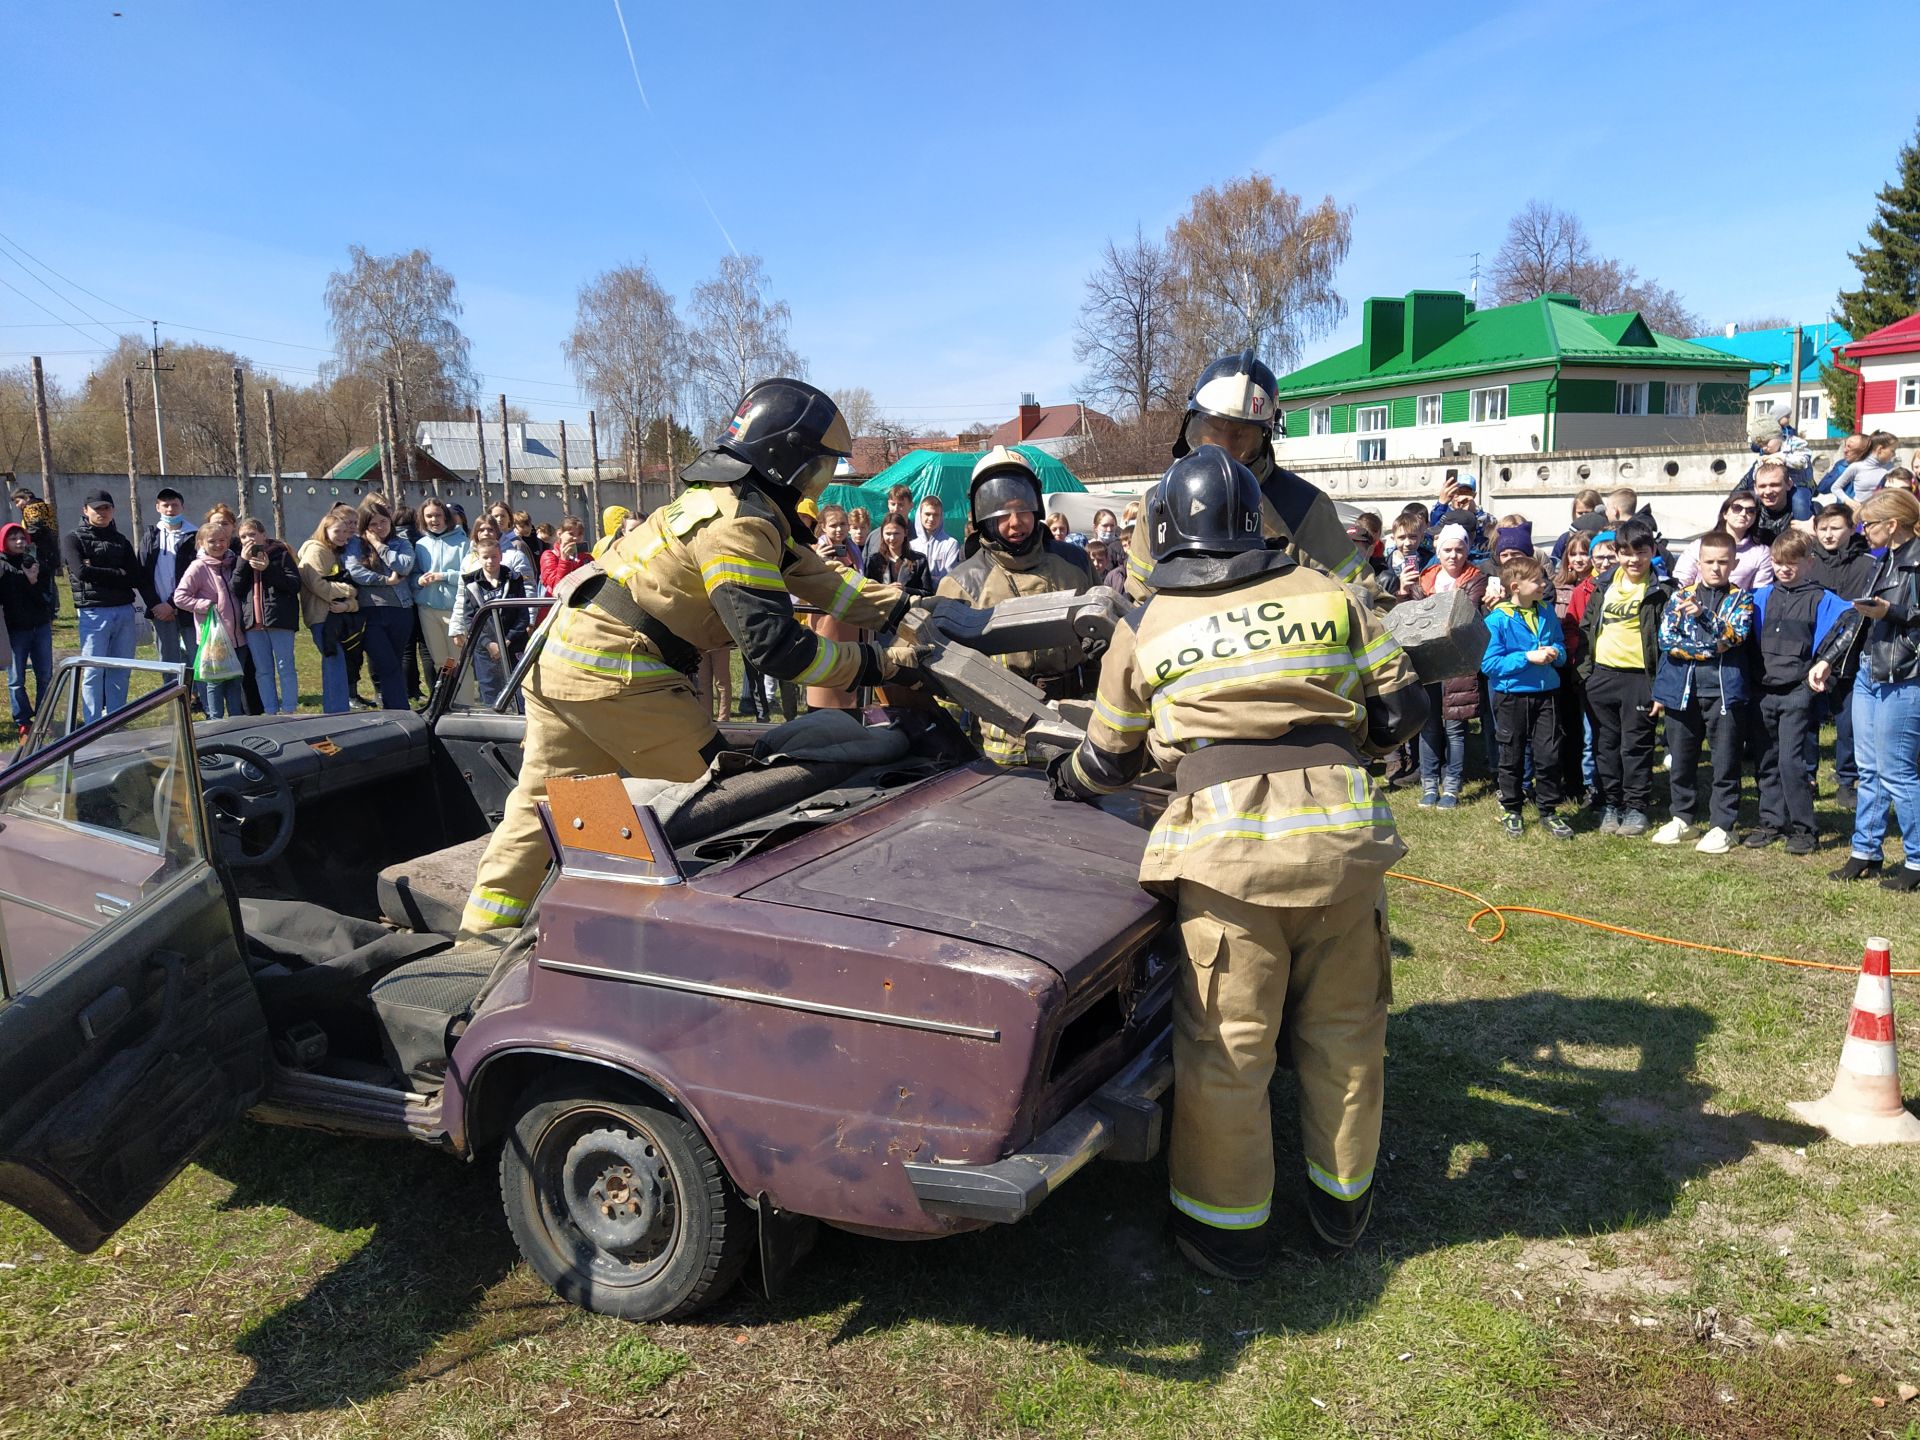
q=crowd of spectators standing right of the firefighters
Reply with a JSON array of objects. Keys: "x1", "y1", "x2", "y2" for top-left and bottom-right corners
[{"x1": 1350, "y1": 451, "x2": 1920, "y2": 891}]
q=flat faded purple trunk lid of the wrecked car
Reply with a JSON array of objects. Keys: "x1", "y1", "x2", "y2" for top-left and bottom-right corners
[{"x1": 745, "y1": 772, "x2": 1169, "y2": 985}]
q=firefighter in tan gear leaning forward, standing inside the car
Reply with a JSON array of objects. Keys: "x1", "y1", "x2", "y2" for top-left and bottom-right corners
[{"x1": 461, "y1": 380, "x2": 975, "y2": 933}]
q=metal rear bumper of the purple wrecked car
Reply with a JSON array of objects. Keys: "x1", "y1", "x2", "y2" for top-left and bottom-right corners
[{"x1": 906, "y1": 1029, "x2": 1173, "y2": 1223}]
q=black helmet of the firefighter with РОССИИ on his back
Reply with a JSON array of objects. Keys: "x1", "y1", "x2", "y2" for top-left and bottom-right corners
[{"x1": 1146, "y1": 445, "x2": 1292, "y2": 589}]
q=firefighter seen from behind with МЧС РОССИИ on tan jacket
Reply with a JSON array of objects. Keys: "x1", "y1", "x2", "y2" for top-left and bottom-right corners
[{"x1": 1052, "y1": 445, "x2": 1427, "y2": 1279}]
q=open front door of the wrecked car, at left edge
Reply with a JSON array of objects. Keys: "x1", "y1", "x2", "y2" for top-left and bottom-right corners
[{"x1": 0, "y1": 659, "x2": 267, "y2": 1250}]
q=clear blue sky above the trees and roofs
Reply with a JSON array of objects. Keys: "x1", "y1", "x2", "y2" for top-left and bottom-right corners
[{"x1": 0, "y1": 0, "x2": 1920, "y2": 428}]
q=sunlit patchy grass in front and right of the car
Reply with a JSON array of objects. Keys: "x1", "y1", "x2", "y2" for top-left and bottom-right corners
[{"x1": 0, "y1": 606, "x2": 1920, "y2": 1440}]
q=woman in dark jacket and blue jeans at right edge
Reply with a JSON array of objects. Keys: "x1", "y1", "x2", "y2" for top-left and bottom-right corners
[{"x1": 1807, "y1": 488, "x2": 1920, "y2": 891}]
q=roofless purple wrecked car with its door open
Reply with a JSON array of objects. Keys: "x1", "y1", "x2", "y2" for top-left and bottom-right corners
[{"x1": 0, "y1": 607, "x2": 1177, "y2": 1319}]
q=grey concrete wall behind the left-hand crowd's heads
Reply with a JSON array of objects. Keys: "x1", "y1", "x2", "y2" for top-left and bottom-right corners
[{"x1": 24, "y1": 472, "x2": 668, "y2": 547}]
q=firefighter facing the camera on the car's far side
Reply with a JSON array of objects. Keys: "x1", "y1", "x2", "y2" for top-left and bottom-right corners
[{"x1": 935, "y1": 445, "x2": 1090, "y2": 764}]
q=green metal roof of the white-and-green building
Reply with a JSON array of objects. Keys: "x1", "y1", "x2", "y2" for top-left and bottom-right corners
[{"x1": 1281, "y1": 290, "x2": 1745, "y2": 399}]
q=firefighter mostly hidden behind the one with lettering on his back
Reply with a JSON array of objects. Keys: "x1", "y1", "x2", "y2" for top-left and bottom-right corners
[{"x1": 1127, "y1": 360, "x2": 1392, "y2": 611}]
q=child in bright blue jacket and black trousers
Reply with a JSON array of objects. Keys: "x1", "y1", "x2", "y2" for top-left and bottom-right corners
[{"x1": 1480, "y1": 555, "x2": 1572, "y2": 839}]
